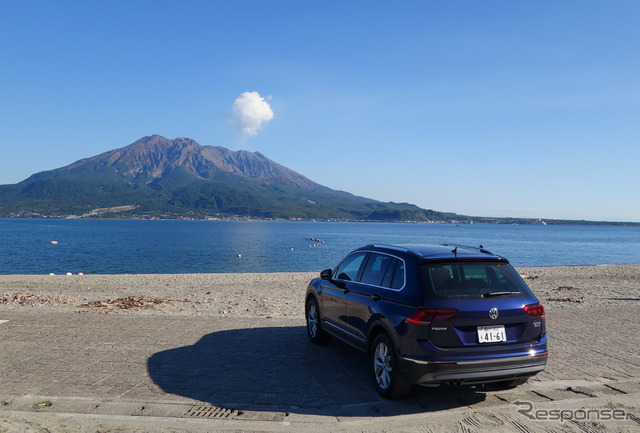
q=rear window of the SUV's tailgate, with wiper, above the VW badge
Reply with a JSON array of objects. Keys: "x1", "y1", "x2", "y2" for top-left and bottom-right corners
[{"x1": 420, "y1": 262, "x2": 532, "y2": 299}]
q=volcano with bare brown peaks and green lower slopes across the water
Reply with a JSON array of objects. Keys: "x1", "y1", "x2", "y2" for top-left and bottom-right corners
[{"x1": 0, "y1": 135, "x2": 457, "y2": 221}]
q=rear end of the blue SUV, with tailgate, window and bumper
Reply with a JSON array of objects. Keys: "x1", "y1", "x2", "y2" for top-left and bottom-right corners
[{"x1": 400, "y1": 258, "x2": 547, "y2": 384}]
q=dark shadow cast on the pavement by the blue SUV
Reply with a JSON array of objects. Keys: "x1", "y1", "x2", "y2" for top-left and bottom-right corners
[{"x1": 147, "y1": 326, "x2": 485, "y2": 416}]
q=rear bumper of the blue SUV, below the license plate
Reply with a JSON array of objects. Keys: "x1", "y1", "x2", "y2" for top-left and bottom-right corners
[{"x1": 399, "y1": 349, "x2": 547, "y2": 385}]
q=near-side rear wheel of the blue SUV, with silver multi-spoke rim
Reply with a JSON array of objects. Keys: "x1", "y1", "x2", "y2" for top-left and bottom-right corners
[{"x1": 370, "y1": 333, "x2": 411, "y2": 399}]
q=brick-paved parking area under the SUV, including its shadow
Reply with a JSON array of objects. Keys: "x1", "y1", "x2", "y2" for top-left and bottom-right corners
[{"x1": 0, "y1": 305, "x2": 640, "y2": 432}]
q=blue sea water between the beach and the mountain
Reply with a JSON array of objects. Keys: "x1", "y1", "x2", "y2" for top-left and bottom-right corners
[{"x1": 0, "y1": 219, "x2": 640, "y2": 274}]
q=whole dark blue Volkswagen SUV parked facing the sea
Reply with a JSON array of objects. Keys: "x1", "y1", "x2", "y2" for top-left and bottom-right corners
[{"x1": 305, "y1": 245, "x2": 547, "y2": 398}]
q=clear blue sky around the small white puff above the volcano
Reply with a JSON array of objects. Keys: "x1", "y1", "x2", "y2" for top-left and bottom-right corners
[{"x1": 0, "y1": 0, "x2": 640, "y2": 221}]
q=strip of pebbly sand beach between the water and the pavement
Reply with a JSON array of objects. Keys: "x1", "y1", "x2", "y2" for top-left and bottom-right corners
[{"x1": 0, "y1": 265, "x2": 640, "y2": 318}]
